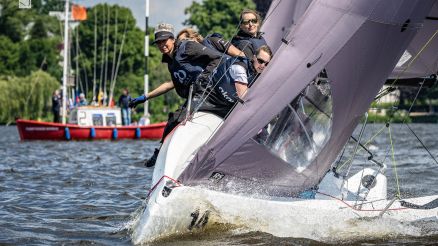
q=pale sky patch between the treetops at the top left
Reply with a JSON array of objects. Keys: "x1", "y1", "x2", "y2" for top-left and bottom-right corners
[{"x1": 79, "y1": 0, "x2": 201, "y2": 32}]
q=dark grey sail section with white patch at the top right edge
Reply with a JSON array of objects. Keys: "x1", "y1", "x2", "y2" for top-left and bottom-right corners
[{"x1": 390, "y1": 2, "x2": 438, "y2": 78}]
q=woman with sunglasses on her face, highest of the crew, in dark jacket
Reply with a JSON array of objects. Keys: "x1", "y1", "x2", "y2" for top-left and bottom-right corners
[{"x1": 231, "y1": 9, "x2": 266, "y2": 58}]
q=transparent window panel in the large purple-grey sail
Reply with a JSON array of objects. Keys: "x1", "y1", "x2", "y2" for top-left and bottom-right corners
[{"x1": 254, "y1": 78, "x2": 332, "y2": 172}]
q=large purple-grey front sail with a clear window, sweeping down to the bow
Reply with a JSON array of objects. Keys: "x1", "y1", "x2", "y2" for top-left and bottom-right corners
[{"x1": 179, "y1": 0, "x2": 435, "y2": 196}]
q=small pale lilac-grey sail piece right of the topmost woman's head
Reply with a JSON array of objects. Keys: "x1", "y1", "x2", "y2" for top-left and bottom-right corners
[{"x1": 261, "y1": 0, "x2": 312, "y2": 53}]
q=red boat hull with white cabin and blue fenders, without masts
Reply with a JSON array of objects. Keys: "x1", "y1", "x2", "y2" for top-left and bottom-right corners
[{"x1": 16, "y1": 107, "x2": 166, "y2": 140}]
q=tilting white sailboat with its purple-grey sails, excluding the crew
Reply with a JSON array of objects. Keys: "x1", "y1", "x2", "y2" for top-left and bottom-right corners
[{"x1": 132, "y1": 0, "x2": 438, "y2": 244}]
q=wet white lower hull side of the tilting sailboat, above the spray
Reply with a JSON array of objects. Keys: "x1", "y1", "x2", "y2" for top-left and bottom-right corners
[{"x1": 133, "y1": 187, "x2": 438, "y2": 244}]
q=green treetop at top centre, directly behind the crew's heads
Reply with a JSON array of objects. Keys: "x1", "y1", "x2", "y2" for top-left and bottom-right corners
[{"x1": 184, "y1": 0, "x2": 255, "y2": 39}]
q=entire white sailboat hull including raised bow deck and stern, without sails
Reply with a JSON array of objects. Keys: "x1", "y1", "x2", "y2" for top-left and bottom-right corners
[{"x1": 132, "y1": 114, "x2": 438, "y2": 244}]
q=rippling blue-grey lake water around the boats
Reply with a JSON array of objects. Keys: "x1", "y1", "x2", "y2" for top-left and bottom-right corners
[{"x1": 0, "y1": 124, "x2": 438, "y2": 245}]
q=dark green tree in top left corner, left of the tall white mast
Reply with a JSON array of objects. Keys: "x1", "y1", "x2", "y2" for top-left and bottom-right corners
[{"x1": 0, "y1": 0, "x2": 61, "y2": 78}]
